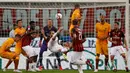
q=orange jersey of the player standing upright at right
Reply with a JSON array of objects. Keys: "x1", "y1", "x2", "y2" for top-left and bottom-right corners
[{"x1": 96, "y1": 22, "x2": 111, "y2": 43}]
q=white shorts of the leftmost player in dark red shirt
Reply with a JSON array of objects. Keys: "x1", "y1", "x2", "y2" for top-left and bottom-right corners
[{"x1": 22, "y1": 45, "x2": 40, "y2": 57}]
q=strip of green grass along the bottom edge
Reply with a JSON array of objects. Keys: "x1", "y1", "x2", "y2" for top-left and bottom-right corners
[{"x1": 0, "y1": 70, "x2": 127, "y2": 73}]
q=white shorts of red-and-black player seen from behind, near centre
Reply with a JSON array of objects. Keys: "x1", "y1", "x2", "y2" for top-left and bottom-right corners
[{"x1": 70, "y1": 51, "x2": 83, "y2": 63}]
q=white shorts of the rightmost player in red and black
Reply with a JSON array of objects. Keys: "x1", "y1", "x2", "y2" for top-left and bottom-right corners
[{"x1": 110, "y1": 46, "x2": 125, "y2": 55}]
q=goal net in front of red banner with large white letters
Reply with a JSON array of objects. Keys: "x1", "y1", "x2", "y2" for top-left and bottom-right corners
[{"x1": 0, "y1": 2, "x2": 129, "y2": 45}]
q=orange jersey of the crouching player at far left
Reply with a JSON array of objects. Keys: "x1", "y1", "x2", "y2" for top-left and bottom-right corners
[{"x1": 0, "y1": 38, "x2": 14, "y2": 52}]
